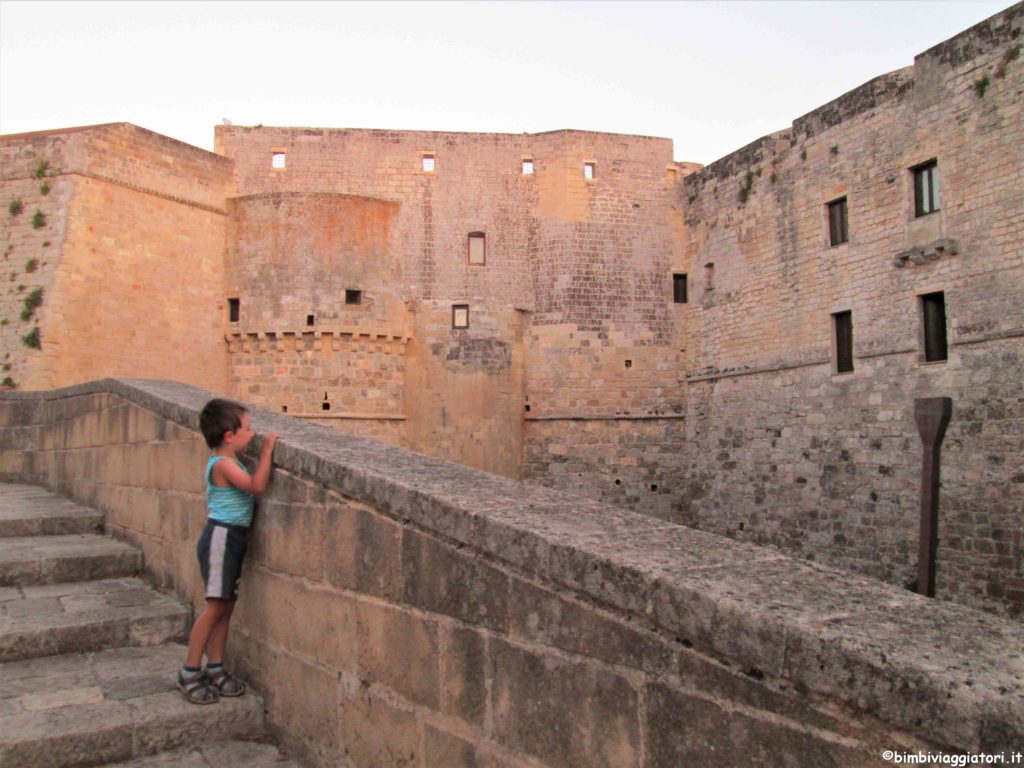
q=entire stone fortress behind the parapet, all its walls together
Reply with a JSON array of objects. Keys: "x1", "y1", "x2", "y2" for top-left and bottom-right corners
[{"x1": 0, "y1": 4, "x2": 1024, "y2": 615}]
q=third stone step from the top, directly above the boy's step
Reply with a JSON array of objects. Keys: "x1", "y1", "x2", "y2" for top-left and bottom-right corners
[{"x1": 0, "y1": 578, "x2": 188, "y2": 663}]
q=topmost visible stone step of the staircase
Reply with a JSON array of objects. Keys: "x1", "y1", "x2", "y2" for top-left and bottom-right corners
[{"x1": 0, "y1": 484, "x2": 103, "y2": 538}]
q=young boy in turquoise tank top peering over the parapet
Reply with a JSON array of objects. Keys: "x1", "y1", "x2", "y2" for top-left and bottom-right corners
[{"x1": 178, "y1": 399, "x2": 278, "y2": 703}]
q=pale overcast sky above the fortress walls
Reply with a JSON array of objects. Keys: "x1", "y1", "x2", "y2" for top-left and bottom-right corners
[{"x1": 0, "y1": 0, "x2": 1012, "y2": 163}]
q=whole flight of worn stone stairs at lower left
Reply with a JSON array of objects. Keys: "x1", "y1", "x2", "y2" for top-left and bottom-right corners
[{"x1": 0, "y1": 483, "x2": 299, "y2": 768}]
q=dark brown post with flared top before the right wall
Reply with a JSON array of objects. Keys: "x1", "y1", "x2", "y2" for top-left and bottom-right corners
[{"x1": 913, "y1": 397, "x2": 953, "y2": 597}]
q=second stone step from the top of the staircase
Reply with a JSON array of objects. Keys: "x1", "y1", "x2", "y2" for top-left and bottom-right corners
[{"x1": 0, "y1": 534, "x2": 142, "y2": 587}]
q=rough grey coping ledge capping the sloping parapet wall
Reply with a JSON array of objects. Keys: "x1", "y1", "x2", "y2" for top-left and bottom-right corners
[{"x1": 0, "y1": 379, "x2": 1024, "y2": 752}]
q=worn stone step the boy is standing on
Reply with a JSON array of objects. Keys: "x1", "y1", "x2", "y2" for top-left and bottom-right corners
[{"x1": 0, "y1": 644, "x2": 263, "y2": 768}]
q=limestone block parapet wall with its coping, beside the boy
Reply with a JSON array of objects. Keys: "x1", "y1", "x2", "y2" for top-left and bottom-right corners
[{"x1": 0, "y1": 380, "x2": 1024, "y2": 768}]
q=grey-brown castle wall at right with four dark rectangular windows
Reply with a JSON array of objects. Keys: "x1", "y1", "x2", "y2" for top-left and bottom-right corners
[{"x1": 674, "y1": 5, "x2": 1024, "y2": 614}]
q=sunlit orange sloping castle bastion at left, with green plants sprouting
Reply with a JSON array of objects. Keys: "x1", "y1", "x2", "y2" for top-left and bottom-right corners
[{"x1": 2, "y1": 124, "x2": 230, "y2": 389}]
